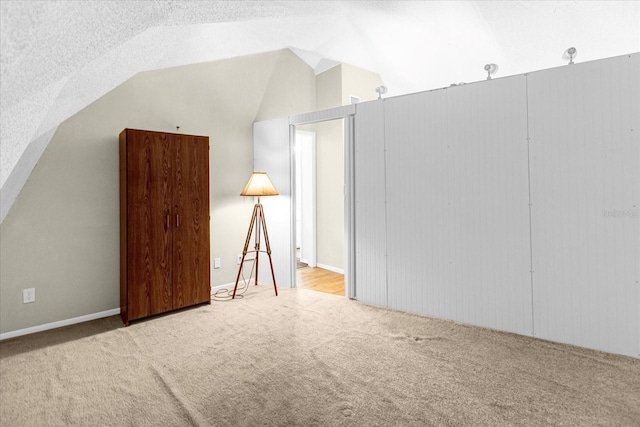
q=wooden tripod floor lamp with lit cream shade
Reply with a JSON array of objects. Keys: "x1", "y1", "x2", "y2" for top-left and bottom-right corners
[{"x1": 231, "y1": 172, "x2": 278, "y2": 299}]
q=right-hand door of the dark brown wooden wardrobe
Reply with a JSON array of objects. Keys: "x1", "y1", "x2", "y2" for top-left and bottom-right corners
[{"x1": 173, "y1": 135, "x2": 211, "y2": 308}]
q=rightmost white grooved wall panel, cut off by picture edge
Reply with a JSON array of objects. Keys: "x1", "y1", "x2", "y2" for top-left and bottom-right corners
[{"x1": 528, "y1": 54, "x2": 640, "y2": 357}]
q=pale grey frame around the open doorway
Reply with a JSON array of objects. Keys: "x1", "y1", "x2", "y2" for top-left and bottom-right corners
[{"x1": 289, "y1": 104, "x2": 357, "y2": 299}]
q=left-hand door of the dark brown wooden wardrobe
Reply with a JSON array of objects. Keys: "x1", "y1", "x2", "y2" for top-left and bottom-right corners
[{"x1": 126, "y1": 130, "x2": 173, "y2": 319}]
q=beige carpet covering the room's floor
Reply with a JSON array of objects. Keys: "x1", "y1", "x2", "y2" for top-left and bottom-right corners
[{"x1": 0, "y1": 285, "x2": 640, "y2": 426}]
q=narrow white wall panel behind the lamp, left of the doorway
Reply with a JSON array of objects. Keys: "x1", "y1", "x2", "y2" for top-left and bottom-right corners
[{"x1": 253, "y1": 118, "x2": 295, "y2": 288}]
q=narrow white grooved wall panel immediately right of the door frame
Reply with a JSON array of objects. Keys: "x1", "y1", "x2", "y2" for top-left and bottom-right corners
[{"x1": 354, "y1": 101, "x2": 387, "y2": 306}]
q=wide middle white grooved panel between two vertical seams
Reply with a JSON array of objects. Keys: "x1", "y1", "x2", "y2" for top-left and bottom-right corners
[{"x1": 384, "y1": 77, "x2": 532, "y2": 334}]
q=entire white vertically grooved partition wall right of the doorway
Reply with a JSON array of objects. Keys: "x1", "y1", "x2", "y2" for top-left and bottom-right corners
[{"x1": 355, "y1": 54, "x2": 640, "y2": 357}]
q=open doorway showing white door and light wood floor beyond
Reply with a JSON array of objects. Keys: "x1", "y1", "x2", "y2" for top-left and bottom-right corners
[{"x1": 293, "y1": 118, "x2": 346, "y2": 295}]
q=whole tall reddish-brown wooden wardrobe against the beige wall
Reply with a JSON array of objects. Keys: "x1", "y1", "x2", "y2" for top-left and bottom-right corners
[{"x1": 120, "y1": 129, "x2": 211, "y2": 325}]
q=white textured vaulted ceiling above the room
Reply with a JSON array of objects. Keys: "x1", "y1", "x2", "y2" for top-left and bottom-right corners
[{"x1": 0, "y1": 0, "x2": 640, "y2": 218}]
